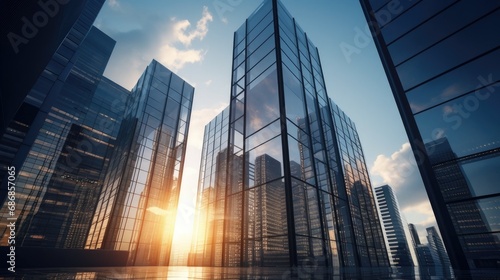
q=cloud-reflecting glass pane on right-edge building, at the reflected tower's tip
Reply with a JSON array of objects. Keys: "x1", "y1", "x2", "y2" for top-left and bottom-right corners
[{"x1": 415, "y1": 93, "x2": 500, "y2": 159}]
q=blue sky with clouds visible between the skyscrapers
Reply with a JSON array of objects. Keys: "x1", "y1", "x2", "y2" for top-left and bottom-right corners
[{"x1": 95, "y1": 0, "x2": 436, "y2": 262}]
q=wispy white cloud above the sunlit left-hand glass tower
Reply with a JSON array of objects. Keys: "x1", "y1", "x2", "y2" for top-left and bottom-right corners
[{"x1": 101, "y1": 6, "x2": 212, "y2": 89}]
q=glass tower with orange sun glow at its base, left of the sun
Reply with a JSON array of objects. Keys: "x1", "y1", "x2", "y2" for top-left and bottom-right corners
[{"x1": 86, "y1": 61, "x2": 194, "y2": 265}]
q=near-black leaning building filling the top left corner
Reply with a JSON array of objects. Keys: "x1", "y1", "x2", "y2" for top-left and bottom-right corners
[{"x1": 0, "y1": 0, "x2": 105, "y2": 203}]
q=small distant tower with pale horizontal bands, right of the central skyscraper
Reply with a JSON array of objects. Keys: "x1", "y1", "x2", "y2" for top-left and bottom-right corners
[{"x1": 375, "y1": 185, "x2": 418, "y2": 266}]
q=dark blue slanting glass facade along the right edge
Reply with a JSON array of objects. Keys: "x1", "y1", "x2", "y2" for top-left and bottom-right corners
[{"x1": 361, "y1": 0, "x2": 500, "y2": 270}]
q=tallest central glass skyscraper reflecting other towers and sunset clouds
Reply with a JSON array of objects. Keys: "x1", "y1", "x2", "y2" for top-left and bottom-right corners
[{"x1": 189, "y1": 0, "x2": 389, "y2": 267}]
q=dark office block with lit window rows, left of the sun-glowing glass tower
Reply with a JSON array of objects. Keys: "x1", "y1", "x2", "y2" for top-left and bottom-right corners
[{"x1": 1, "y1": 28, "x2": 128, "y2": 248}]
